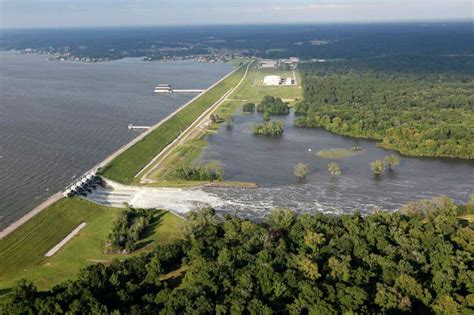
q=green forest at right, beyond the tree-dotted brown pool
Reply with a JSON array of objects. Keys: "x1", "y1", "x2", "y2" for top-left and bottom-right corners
[{"x1": 295, "y1": 56, "x2": 474, "y2": 159}]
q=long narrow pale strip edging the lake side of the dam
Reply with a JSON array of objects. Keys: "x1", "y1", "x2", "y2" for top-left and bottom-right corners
[{"x1": 0, "y1": 62, "x2": 242, "y2": 240}]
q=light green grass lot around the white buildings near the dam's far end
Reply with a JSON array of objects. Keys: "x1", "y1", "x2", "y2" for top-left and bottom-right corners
[{"x1": 230, "y1": 67, "x2": 303, "y2": 105}]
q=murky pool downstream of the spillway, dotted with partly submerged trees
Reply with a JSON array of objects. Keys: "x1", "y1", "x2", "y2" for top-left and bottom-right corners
[{"x1": 201, "y1": 114, "x2": 474, "y2": 219}]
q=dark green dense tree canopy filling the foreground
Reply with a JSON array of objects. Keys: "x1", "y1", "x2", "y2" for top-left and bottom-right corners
[{"x1": 4, "y1": 197, "x2": 474, "y2": 314}]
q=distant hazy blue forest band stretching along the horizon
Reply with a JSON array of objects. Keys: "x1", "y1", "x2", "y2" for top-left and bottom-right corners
[{"x1": 0, "y1": 21, "x2": 474, "y2": 59}]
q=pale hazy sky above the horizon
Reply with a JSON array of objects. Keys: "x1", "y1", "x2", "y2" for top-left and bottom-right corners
[{"x1": 0, "y1": 0, "x2": 474, "y2": 28}]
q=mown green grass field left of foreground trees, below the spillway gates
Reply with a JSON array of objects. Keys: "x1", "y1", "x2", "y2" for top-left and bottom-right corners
[{"x1": 0, "y1": 198, "x2": 183, "y2": 295}]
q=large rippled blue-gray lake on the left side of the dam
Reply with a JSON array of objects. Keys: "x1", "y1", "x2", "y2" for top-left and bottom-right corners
[{"x1": 0, "y1": 52, "x2": 232, "y2": 229}]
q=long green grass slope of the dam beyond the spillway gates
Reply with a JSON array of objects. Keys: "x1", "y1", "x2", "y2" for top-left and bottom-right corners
[{"x1": 99, "y1": 65, "x2": 250, "y2": 184}]
